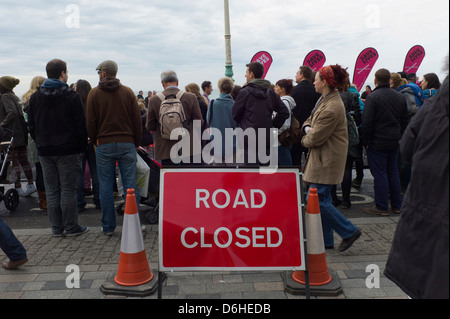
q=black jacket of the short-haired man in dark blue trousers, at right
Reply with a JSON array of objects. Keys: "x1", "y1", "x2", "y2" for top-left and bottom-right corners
[{"x1": 361, "y1": 83, "x2": 408, "y2": 151}]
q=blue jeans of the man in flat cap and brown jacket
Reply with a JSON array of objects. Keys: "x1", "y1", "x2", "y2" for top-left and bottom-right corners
[{"x1": 96, "y1": 143, "x2": 140, "y2": 233}]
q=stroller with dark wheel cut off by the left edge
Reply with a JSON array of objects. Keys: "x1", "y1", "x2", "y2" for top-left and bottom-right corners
[{"x1": 0, "y1": 127, "x2": 19, "y2": 211}]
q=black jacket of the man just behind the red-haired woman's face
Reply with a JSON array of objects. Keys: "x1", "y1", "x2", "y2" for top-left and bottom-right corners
[{"x1": 292, "y1": 80, "x2": 321, "y2": 127}]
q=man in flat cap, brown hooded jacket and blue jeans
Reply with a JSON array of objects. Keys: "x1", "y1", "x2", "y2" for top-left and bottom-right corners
[{"x1": 86, "y1": 60, "x2": 142, "y2": 236}]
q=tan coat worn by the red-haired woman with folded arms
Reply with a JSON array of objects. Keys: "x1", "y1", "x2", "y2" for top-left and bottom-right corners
[{"x1": 302, "y1": 91, "x2": 348, "y2": 185}]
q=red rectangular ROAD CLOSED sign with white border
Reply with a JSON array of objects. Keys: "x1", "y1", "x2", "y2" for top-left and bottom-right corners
[{"x1": 159, "y1": 169, "x2": 305, "y2": 271}]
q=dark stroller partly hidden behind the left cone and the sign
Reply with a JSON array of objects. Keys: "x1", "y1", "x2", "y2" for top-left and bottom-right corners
[{"x1": 116, "y1": 148, "x2": 161, "y2": 225}]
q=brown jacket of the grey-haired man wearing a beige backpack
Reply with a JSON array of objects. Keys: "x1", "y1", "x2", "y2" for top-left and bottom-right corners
[{"x1": 146, "y1": 88, "x2": 203, "y2": 160}]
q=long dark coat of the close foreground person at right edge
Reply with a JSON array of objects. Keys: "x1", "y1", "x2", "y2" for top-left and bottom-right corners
[{"x1": 384, "y1": 76, "x2": 449, "y2": 299}]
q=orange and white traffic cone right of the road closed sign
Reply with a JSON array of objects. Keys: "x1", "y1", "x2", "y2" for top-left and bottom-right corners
[{"x1": 292, "y1": 188, "x2": 332, "y2": 286}]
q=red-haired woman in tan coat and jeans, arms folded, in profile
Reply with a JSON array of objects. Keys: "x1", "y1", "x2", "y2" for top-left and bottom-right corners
[{"x1": 302, "y1": 65, "x2": 361, "y2": 252}]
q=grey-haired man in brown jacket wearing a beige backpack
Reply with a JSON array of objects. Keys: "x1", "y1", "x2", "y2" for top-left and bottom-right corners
[{"x1": 146, "y1": 71, "x2": 203, "y2": 166}]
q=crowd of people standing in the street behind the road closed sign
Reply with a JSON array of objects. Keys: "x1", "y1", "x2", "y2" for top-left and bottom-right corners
[{"x1": 0, "y1": 59, "x2": 448, "y2": 300}]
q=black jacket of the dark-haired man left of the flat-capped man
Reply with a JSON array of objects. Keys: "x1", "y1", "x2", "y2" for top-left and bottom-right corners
[{"x1": 28, "y1": 86, "x2": 87, "y2": 156}]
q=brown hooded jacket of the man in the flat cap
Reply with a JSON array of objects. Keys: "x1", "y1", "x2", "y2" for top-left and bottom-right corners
[{"x1": 86, "y1": 78, "x2": 142, "y2": 147}]
